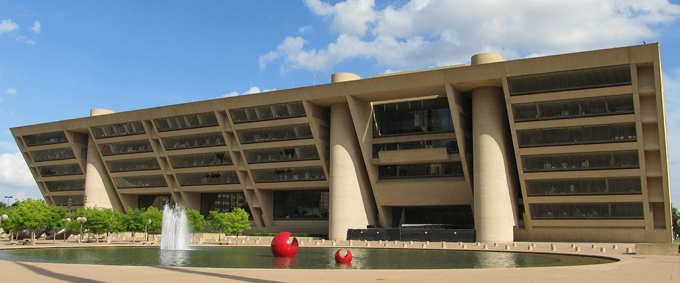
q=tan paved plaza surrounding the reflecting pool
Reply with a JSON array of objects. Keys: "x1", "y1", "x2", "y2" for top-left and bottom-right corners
[{"x1": 0, "y1": 237, "x2": 680, "y2": 283}]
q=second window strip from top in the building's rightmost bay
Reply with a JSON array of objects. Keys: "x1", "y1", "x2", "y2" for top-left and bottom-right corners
[{"x1": 512, "y1": 94, "x2": 634, "y2": 122}]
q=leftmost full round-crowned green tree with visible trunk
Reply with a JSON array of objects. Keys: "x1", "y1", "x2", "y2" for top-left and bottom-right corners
[{"x1": 12, "y1": 199, "x2": 52, "y2": 245}]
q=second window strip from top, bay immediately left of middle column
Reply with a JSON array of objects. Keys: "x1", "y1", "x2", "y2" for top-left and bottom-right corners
[{"x1": 237, "y1": 124, "x2": 312, "y2": 144}]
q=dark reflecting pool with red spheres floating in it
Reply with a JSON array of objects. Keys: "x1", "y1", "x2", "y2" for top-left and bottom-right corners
[{"x1": 0, "y1": 247, "x2": 613, "y2": 269}]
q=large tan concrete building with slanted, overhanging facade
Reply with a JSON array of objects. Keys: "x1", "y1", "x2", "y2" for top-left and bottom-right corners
[{"x1": 11, "y1": 44, "x2": 672, "y2": 242}]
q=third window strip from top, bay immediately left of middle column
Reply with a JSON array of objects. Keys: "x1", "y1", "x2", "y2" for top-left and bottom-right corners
[{"x1": 244, "y1": 145, "x2": 319, "y2": 163}]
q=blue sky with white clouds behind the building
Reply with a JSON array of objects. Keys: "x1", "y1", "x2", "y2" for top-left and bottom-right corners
[{"x1": 0, "y1": 0, "x2": 680, "y2": 206}]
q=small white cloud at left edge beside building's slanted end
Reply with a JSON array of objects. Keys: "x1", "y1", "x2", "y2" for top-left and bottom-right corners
[{"x1": 0, "y1": 152, "x2": 35, "y2": 188}]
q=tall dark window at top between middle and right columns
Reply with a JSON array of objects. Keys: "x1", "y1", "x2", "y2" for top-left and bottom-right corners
[{"x1": 373, "y1": 98, "x2": 453, "y2": 137}]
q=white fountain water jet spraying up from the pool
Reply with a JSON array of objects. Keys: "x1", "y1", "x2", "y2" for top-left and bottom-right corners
[{"x1": 161, "y1": 204, "x2": 189, "y2": 251}]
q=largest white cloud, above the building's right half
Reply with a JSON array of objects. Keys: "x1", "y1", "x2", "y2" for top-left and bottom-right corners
[{"x1": 259, "y1": 0, "x2": 680, "y2": 72}]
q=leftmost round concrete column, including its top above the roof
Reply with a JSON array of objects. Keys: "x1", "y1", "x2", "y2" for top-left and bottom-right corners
[{"x1": 85, "y1": 109, "x2": 123, "y2": 211}]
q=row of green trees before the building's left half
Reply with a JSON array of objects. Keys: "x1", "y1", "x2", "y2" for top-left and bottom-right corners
[{"x1": 0, "y1": 199, "x2": 250, "y2": 244}]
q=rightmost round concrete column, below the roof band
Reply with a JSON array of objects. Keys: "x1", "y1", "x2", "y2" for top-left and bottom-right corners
[{"x1": 472, "y1": 87, "x2": 516, "y2": 242}]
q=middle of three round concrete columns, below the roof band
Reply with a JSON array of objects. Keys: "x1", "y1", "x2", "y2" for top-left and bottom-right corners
[{"x1": 328, "y1": 102, "x2": 376, "y2": 240}]
